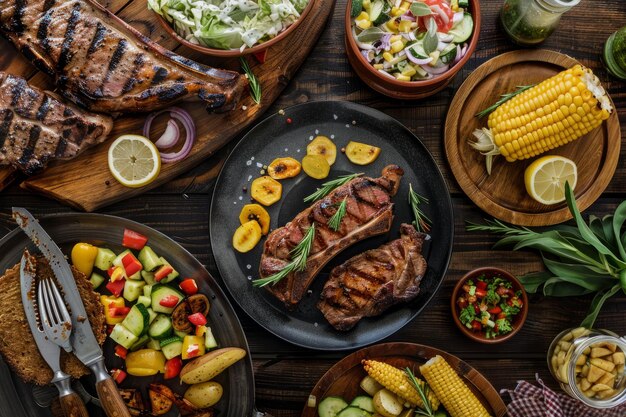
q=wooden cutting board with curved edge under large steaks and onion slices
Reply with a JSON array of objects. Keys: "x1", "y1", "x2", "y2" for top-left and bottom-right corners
[{"x1": 0, "y1": 0, "x2": 335, "y2": 211}]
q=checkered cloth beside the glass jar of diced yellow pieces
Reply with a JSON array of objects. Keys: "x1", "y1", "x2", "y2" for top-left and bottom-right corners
[{"x1": 500, "y1": 374, "x2": 626, "y2": 417}]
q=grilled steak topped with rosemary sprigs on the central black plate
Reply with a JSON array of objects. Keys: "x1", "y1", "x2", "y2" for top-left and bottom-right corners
[{"x1": 259, "y1": 165, "x2": 404, "y2": 307}]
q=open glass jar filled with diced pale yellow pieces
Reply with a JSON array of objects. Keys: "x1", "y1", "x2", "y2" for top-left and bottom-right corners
[{"x1": 548, "y1": 327, "x2": 626, "y2": 408}]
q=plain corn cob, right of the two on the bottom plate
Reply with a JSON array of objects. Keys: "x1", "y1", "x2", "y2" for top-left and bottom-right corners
[{"x1": 420, "y1": 355, "x2": 490, "y2": 417}]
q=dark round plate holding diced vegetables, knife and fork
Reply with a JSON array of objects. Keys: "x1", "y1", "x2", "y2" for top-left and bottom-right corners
[{"x1": 0, "y1": 214, "x2": 254, "y2": 417}]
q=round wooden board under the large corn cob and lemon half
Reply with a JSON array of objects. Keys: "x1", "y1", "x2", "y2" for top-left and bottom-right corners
[{"x1": 445, "y1": 50, "x2": 621, "y2": 226}]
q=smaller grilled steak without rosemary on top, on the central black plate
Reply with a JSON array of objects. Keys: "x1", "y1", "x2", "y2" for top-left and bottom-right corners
[{"x1": 317, "y1": 224, "x2": 427, "y2": 330}]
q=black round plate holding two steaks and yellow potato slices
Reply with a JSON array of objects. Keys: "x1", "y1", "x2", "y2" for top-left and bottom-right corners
[{"x1": 209, "y1": 101, "x2": 454, "y2": 350}]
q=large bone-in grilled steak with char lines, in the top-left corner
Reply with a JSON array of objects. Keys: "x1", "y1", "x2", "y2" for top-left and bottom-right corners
[{"x1": 0, "y1": 0, "x2": 247, "y2": 112}]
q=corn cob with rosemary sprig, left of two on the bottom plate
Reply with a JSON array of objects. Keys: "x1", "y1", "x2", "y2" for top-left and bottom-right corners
[{"x1": 361, "y1": 360, "x2": 439, "y2": 410}]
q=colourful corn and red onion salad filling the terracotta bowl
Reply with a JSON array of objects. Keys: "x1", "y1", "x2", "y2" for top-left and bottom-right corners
[{"x1": 350, "y1": 0, "x2": 474, "y2": 81}]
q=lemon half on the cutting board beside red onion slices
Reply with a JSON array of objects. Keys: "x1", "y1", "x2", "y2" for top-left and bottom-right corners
[{"x1": 109, "y1": 135, "x2": 161, "y2": 188}]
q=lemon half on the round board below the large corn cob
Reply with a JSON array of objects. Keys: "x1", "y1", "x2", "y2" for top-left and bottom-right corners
[{"x1": 524, "y1": 155, "x2": 578, "y2": 205}]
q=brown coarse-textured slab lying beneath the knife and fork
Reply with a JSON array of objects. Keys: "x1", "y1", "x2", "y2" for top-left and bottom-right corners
[{"x1": 0, "y1": 257, "x2": 106, "y2": 385}]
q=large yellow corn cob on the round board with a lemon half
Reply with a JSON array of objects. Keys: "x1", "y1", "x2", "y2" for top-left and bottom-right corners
[{"x1": 471, "y1": 65, "x2": 613, "y2": 172}]
